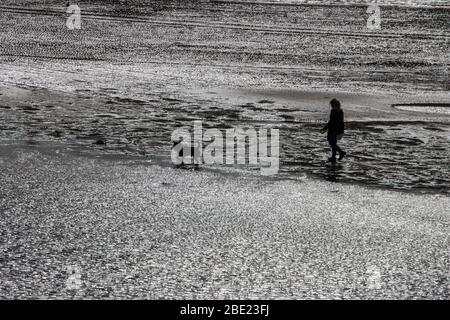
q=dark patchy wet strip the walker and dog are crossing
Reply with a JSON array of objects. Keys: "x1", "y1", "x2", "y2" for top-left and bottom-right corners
[{"x1": 0, "y1": 85, "x2": 450, "y2": 193}]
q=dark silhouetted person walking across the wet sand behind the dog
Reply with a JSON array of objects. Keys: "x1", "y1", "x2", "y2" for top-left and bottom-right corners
[{"x1": 321, "y1": 99, "x2": 346, "y2": 163}]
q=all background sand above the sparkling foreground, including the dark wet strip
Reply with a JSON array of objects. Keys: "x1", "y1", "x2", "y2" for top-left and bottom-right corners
[{"x1": 0, "y1": 1, "x2": 450, "y2": 193}]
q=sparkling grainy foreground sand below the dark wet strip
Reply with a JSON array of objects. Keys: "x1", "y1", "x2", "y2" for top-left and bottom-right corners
[{"x1": 0, "y1": 143, "x2": 450, "y2": 299}]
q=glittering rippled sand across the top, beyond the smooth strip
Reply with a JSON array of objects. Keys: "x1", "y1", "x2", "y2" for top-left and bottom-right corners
[{"x1": 0, "y1": 1, "x2": 449, "y2": 90}]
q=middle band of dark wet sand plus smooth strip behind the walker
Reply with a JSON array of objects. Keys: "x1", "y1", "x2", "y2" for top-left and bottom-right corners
[{"x1": 0, "y1": 82, "x2": 450, "y2": 194}]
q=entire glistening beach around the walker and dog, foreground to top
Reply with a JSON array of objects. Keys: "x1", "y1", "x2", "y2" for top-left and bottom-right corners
[{"x1": 0, "y1": 0, "x2": 450, "y2": 300}]
